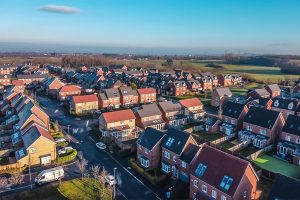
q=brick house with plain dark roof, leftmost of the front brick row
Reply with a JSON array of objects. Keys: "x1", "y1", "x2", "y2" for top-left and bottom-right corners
[{"x1": 137, "y1": 128, "x2": 165, "y2": 169}]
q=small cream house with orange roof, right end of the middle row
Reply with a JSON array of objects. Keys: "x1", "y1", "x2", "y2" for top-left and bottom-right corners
[{"x1": 179, "y1": 97, "x2": 205, "y2": 120}]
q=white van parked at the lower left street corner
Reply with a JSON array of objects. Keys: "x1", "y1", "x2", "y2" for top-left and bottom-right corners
[{"x1": 34, "y1": 167, "x2": 64, "y2": 185}]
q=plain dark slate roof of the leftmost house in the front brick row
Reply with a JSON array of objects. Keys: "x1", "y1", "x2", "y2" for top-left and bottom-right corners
[{"x1": 137, "y1": 127, "x2": 165, "y2": 150}]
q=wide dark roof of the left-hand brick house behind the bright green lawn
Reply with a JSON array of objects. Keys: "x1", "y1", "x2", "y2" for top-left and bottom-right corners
[{"x1": 244, "y1": 107, "x2": 280, "y2": 129}]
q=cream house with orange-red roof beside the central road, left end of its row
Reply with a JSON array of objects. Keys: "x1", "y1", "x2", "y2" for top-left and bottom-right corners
[{"x1": 99, "y1": 109, "x2": 138, "y2": 149}]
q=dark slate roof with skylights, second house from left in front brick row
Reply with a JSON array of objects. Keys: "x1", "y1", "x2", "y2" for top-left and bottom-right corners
[{"x1": 162, "y1": 129, "x2": 190, "y2": 155}]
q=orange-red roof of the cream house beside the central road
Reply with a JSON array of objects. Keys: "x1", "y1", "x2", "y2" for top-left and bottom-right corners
[{"x1": 103, "y1": 109, "x2": 135, "y2": 123}]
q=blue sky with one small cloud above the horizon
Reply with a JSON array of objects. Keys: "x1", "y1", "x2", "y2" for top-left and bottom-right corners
[{"x1": 0, "y1": 0, "x2": 300, "y2": 54}]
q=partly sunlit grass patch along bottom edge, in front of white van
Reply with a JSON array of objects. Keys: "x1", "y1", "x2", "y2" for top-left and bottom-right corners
[{"x1": 3, "y1": 179, "x2": 111, "y2": 200}]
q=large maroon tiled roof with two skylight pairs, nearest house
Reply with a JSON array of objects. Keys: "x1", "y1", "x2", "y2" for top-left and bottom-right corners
[{"x1": 191, "y1": 145, "x2": 256, "y2": 196}]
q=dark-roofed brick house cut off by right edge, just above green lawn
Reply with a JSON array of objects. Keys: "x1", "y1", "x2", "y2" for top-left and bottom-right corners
[{"x1": 277, "y1": 115, "x2": 300, "y2": 165}]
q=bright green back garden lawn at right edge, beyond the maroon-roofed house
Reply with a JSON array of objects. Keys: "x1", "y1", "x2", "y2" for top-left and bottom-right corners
[{"x1": 254, "y1": 155, "x2": 300, "y2": 178}]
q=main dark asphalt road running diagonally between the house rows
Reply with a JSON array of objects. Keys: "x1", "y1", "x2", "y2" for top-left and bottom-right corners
[{"x1": 37, "y1": 96, "x2": 160, "y2": 200}]
